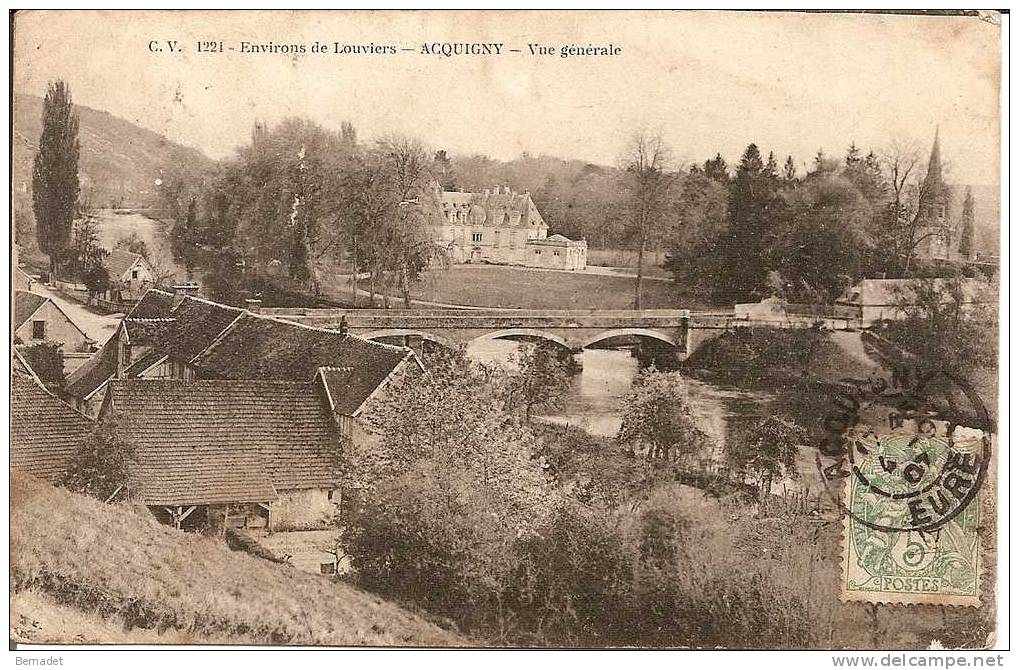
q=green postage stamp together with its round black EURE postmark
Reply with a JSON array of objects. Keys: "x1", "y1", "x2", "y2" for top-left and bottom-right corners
[{"x1": 824, "y1": 373, "x2": 994, "y2": 607}]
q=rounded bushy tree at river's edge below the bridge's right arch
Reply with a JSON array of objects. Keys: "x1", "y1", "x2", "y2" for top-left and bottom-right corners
[{"x1": 615, "y1": 369, "x2": 707, "y2": 461}]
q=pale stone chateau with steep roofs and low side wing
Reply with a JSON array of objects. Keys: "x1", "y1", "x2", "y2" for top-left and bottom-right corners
[{"x1": 431, "y1": 183, "x2": 587, "y2": 270}]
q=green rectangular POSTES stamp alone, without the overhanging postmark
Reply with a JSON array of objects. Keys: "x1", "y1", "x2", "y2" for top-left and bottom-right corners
[{"x1": 842, "y1": 433, "x2": 982, "y2": 606}]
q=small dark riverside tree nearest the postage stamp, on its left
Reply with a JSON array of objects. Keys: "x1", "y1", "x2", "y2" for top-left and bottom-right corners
[{"x1": 726, "y1": 414, "x2": 807, "y2": 496}]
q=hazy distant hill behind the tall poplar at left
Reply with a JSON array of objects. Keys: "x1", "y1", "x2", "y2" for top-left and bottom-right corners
[{"x1": 11, "y1": 95, "x2": 213, "y2": 211}]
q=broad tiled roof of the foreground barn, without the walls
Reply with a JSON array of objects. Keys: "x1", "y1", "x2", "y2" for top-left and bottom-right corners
[{"x1": 109, "y1": 379, "x2": 338, "y2": 505}]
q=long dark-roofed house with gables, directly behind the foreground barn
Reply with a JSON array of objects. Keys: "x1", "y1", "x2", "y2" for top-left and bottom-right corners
[{"x1": 66, "y1": 289, "x2": 423, "y2": 439}]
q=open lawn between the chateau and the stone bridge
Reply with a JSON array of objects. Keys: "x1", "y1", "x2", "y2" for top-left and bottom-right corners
[{"x1": 401, "y1": 265, "x2": 706, "y2": 310}]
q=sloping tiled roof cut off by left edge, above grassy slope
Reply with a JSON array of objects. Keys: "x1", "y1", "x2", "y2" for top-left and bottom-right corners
[{"x1": 10, "y1": 365, "x2": 92, "y2": 483}]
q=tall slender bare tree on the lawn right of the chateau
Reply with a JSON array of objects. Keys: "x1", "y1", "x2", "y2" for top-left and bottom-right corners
[{"x1": 624, "y1": 131, "x2": 675, "y2": 310}]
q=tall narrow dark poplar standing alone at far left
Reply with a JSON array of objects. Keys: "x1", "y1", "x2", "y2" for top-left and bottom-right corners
[{"x1": 32, "y1": 80, "x2": 79, "y2": 275}]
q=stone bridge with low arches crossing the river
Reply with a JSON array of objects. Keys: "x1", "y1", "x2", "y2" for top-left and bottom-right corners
[{"x1": 254, "y1": 308, "x2": 749, "y2": 359}]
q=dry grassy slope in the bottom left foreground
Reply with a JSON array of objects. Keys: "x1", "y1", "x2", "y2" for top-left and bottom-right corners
[{"x1": 10, "y1": 472, "x2": 467, "y2": 647}]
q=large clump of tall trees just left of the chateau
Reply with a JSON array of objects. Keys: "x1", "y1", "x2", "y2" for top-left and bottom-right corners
[{"x1": 162, "y1": 118, "x2": 454, "y2": 303}]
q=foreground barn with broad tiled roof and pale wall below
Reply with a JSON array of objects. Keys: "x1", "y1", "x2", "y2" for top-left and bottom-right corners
[{"x1": 100, "y1": 379, "x2": 340, "y2": 532}]
